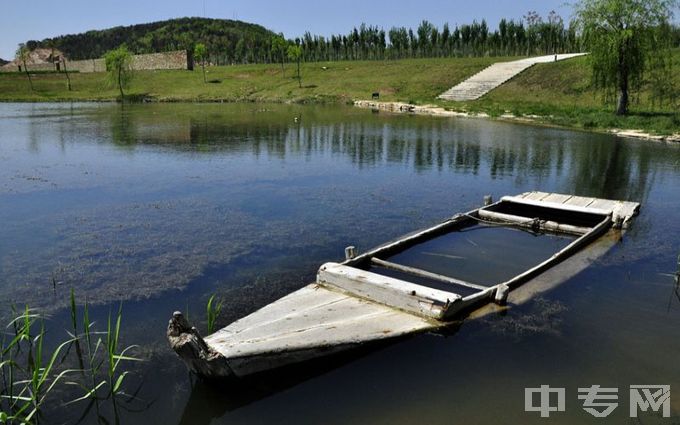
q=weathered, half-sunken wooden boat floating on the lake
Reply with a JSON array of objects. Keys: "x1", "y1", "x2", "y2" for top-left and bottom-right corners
[{"x1": 167, "y1": 192, "x2": 640, "y2": 378}]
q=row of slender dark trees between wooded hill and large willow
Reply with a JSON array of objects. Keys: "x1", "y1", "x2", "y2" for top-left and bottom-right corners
[{"x1": 294, "y1": 11, "x2": 581, "y2": 61}]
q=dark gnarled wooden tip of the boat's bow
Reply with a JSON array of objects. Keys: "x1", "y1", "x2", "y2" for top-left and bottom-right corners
[{"x1": 167, "y1": 311, "x2": 233, "y2": 378}]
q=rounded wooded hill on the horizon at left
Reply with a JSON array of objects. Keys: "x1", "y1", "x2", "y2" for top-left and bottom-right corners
[{"x1": 27, "y1": 18, "x2": 274, "y2": 64}]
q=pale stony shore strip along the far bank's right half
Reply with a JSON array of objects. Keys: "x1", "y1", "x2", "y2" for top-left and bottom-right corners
[{"x1": 354, "y1": 100, "x2": 680, "y2": 143}]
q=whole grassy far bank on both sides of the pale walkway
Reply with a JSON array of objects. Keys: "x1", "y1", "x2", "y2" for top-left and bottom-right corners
[{"x1": 0, "y1": 51, "x2": 680, "y2": 134}]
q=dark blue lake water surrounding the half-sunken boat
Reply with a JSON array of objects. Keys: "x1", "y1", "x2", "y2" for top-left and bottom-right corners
[{"x1": 0, "y1": 104, "x2": 680, "y2": 424}]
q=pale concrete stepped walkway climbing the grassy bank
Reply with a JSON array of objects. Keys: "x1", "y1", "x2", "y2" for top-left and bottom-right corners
[{"x1": 438, "y1": 53, "x2": 586, "y2": 101}]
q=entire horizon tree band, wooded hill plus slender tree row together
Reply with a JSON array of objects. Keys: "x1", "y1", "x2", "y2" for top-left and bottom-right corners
[{"x1": 26, "y1": 11, "x2": 680, "y2": 65}]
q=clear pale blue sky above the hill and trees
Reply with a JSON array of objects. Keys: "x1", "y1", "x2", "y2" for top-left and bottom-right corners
[{"x1": 0, "y1": 0, "x2": 571, "y2": 59}]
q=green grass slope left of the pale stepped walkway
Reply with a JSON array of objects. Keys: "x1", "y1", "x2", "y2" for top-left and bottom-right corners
[{"x1": 0, "y1": 58, "x2": 500, "y2": 103}]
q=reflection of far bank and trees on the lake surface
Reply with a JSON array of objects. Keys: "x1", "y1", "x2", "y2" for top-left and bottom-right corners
[{"x1": 97, "y1": 105, "x2": 680, "y2": 201}]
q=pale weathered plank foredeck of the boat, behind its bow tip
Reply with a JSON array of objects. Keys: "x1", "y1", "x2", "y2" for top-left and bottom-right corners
[{"x1": 205, "y1": 284, "x2": 437, "y2": 358}]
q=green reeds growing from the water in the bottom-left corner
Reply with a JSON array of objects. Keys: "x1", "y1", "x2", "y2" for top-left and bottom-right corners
[{"x1": 0, "y1": 290, "x2": 140, "y2": 424}]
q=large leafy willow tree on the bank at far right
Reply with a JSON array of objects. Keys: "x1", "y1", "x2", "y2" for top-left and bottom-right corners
[{"x1": 574, "y1": 0, "x2": 678, "y2": 115}]
